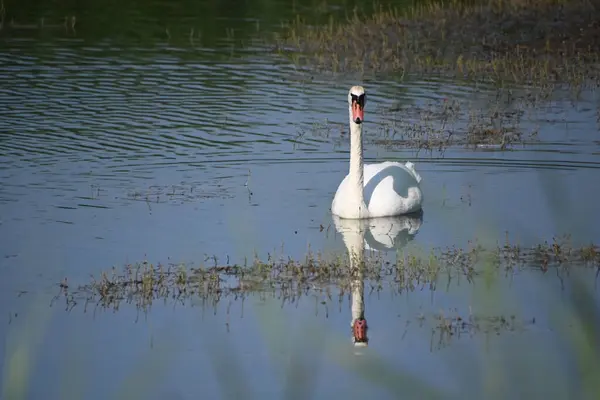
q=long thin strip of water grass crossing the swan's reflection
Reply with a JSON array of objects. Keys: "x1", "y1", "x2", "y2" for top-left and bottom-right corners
[{"x1": 54, "y1": 236, "x2": 600, "y2": 316}]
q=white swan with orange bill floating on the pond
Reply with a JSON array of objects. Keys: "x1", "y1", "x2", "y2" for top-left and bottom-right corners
[{"x1": 331, "y1": 86, "x2": 423, "y2": 219}]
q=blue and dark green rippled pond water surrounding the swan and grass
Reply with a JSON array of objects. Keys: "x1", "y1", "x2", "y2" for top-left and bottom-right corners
[{"x1": 0, "y1": 1, "x2": 600, "y2": 399}]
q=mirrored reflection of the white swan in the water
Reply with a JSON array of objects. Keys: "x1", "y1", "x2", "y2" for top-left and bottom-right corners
[{"x1": 333, "y1": 212, "x2": 423, "y2": 346}]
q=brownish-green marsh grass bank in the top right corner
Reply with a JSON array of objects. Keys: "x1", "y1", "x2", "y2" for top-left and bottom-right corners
[{"x1": 277, "y1": 0, "x2": 600, "y2": 86}]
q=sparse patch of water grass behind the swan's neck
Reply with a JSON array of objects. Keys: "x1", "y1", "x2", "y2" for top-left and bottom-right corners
[{"x1": 304, "y1": 87, "x2": 550, "y2": 153}]
